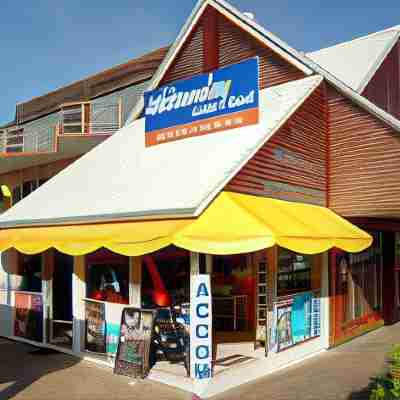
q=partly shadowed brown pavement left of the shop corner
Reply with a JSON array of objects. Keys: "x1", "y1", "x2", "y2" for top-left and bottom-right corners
[{"x1": 0, "y1": 338, "x2": 192, "y2": 400}]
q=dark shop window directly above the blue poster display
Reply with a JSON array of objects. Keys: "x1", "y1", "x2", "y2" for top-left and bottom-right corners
[{"x1": 277, "y1": 248, "x2": 312, "y2": 296}]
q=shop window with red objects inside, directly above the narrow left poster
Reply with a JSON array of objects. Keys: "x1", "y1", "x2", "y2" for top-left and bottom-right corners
[{"x1": 86, "y1": 258, "x2": 129, "y2": 304}]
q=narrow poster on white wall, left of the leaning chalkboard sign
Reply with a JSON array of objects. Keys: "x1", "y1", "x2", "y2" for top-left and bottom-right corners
[{"x1": 85, "y1": 300, "x2": 106, "y2": 353}]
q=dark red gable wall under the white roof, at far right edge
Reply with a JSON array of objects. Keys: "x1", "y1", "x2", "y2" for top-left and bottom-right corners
[{"x1": 362, "y1": 43, "x2": 400, "y2": 118}]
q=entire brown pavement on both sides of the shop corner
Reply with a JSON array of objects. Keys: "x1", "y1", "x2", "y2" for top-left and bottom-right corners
[{"x1": 0, "y1": 323, "x2": 400, "y2": 400}]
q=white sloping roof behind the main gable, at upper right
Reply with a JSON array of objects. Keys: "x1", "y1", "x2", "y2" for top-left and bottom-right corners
[{"x1": 307, "y1": 26, "x2": 400, "y2": 93}]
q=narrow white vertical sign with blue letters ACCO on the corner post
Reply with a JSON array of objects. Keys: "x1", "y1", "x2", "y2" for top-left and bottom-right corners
[{"x1": 190, "y1": 274, "x2": 212, "y2": 380}]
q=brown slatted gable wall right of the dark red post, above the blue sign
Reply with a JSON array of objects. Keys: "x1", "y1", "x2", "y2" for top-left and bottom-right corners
[{"x1": 218, "y1": 15, "x2": 305, "y2": 89}]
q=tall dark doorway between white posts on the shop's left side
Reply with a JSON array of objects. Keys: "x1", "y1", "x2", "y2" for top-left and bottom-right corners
[{"x1": 49, "y1": 251, "x2": 73, "y2": 348}]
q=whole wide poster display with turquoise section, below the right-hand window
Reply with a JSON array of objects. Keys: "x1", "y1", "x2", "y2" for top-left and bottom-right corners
[{"x1": 269, "y1": 292, "x2": 321, "y2": 353}]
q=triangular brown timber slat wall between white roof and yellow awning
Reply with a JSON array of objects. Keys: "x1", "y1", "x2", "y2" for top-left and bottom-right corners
[{"x1": 226, "y1": 85, "x2": 327, "y2": 195}]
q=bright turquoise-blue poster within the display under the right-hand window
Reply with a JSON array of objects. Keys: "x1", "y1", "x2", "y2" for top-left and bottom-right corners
[{"x1": 291, "y1": 292, "x2": 313, "y2": 343}]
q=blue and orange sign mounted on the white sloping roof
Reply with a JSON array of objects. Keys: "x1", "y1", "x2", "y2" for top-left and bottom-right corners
[{"x1": 144, "y1": 58, "x2": 259, "y2": 147}]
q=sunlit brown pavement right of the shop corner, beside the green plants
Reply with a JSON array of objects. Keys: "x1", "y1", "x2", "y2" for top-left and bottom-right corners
[{"x1": 213, "y1": 323, "x2": 400, "y2": 400}]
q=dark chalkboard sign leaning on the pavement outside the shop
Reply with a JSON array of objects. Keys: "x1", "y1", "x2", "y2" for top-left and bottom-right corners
[{"x1": 114, "y1": 307, "x2": 155, "y2": 378}]
